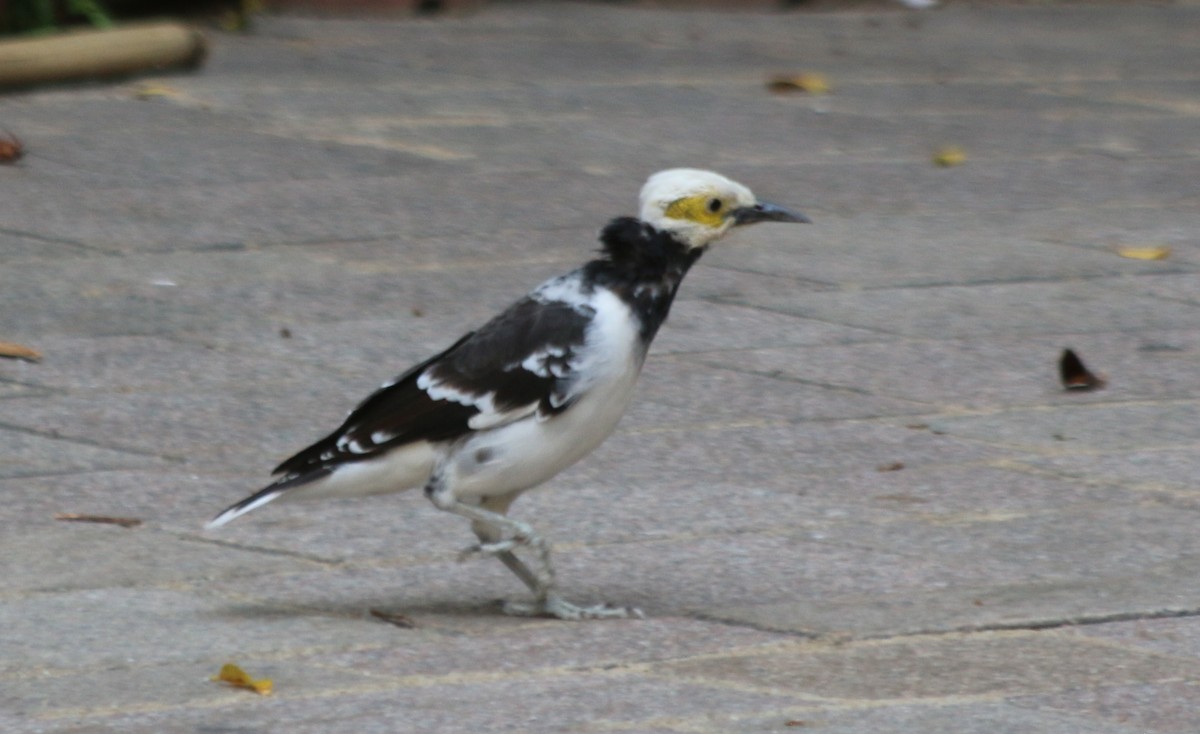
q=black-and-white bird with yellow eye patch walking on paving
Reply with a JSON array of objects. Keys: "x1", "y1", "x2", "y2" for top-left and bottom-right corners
[{"x1": 206, "y1": 168, "x2": 810, "y2": 620}]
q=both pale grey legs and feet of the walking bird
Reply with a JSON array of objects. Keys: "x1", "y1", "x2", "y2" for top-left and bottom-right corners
[{"x1": 427, "y1": 491, "x2": 644, "y2": 620}]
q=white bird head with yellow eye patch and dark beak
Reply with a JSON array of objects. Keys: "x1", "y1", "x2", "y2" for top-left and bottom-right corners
[{"x1": 641, "y1": 168, "x2": 809, "y2": 247}]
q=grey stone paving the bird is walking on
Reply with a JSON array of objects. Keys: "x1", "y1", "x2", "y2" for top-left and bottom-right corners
[{"x1": 0, "y1": 2, "x2": 1200, "y2": 734}]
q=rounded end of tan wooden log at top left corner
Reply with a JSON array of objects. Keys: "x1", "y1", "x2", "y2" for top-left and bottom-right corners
[{"x1": 0, "y1": 23, "x2": 208, "y2": 89}]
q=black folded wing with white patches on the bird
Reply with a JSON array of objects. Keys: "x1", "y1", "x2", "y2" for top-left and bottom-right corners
[{"x1": 275, "y1": 297, "x2": 592, "y2": 476}]
